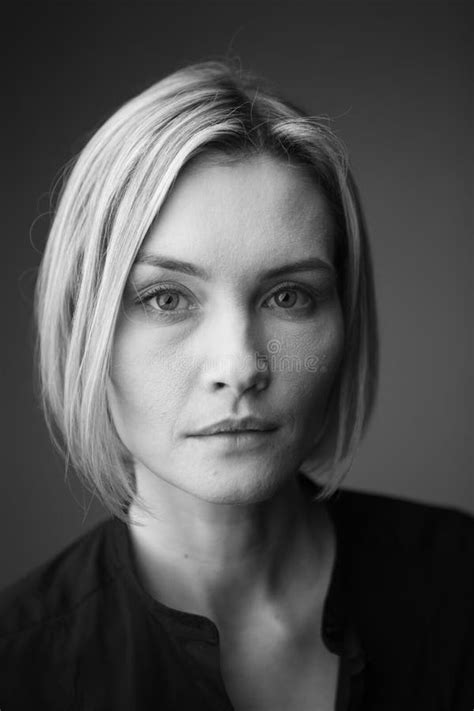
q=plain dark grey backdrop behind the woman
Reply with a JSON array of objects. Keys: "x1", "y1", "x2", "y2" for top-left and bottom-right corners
[{"x1": 0, "y1": 0, "x2": 474, "y2": 585}]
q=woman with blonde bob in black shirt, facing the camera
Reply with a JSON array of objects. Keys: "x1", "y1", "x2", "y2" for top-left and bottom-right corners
[{"x1": 0, "y1": 62, "x2": 474, "y2": 711}]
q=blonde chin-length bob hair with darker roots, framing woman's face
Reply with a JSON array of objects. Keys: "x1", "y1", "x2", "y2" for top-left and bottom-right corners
[{"x1": 35, "y1": 60, "x2": 378, "y2": 520}]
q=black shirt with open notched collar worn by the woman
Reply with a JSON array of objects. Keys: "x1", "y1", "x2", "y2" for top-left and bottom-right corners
[{"x1": 0, "y1": 480, "x2": 474, "y2": 711}]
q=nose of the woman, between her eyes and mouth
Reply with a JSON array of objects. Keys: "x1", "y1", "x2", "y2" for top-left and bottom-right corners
[{"x1": 197, "y1": 307, "x2": 270, "y2": 398}]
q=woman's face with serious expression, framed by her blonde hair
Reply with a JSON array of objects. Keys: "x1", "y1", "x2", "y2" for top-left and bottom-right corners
[{"x1": 108, "y1": 155, "x2": 343, "y2": 504}]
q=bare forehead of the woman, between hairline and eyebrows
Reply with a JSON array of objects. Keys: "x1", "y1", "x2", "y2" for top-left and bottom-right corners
[{"x1": 140, "y1": 154, "x2": 334, "y2": 274}]
